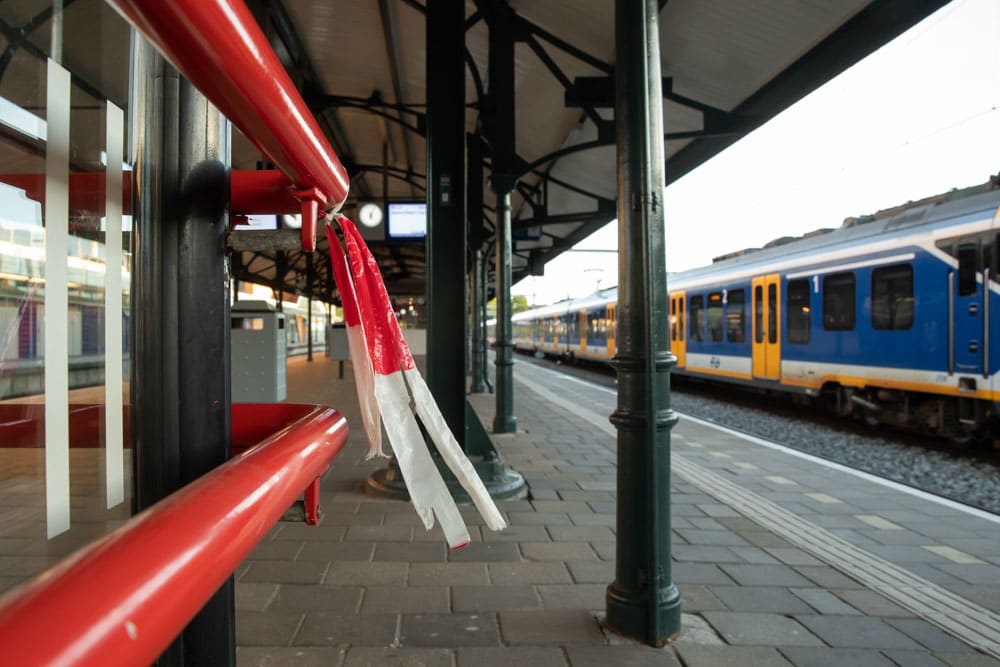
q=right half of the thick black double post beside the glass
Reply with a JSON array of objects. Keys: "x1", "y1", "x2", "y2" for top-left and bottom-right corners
[{"x1": 177, "y1": 74, "x2": 236, "y2": 665}]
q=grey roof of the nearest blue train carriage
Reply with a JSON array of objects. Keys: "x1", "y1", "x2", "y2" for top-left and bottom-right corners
[{"x1": 668, "y1": 175, "x2": 1000, "y2": 289}]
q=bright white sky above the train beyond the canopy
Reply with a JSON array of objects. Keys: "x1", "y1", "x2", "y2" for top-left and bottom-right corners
[{"x1": 512, "y1": 0, "x2": 1000, "y2": 305}]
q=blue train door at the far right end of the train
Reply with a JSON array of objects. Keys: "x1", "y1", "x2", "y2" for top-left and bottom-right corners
[{"x1": 948, "y1": 239, "x2": 988, "y2": 375}]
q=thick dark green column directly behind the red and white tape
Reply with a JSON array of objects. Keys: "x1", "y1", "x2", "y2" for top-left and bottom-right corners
[{"x1": 427, "y1": 0, "x2": 466, "y2": 439}]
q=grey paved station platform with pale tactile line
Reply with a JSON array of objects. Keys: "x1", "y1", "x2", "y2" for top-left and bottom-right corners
[{"x1": 236, "y1": 356, "x2": 1000, "y2": 667}]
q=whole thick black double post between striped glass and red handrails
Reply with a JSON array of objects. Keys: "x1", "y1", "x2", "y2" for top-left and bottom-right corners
[{"x1": 131, "y1": 40, "x2": 236, "y2": 665}]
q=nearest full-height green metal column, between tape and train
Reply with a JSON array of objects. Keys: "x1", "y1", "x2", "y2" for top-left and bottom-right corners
[{"x1": 607, "y1": 0, "x2": 681, "y2": 646}]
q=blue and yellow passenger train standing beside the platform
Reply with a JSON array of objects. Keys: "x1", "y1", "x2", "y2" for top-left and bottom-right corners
[{"x1": 513, "y1": 177, "x2": 1000, "y2": 441}]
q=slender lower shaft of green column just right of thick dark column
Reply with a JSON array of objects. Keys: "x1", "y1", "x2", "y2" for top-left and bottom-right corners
[{"x1": 493, "y1": 191, "x2": 517, "y2": 433}]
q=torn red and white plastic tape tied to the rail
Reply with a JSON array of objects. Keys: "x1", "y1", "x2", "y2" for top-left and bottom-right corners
[{"x1": 327, "y1": 216, "x2": 507, "y2": 549}]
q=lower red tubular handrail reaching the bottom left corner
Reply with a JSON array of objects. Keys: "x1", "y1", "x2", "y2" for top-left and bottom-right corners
[{"x1": 0, "y1": 405, "x2": 348, "y2": 667}]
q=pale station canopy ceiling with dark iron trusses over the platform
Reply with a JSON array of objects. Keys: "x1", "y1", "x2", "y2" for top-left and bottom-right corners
[{"x1": 232, "y1": 0, "x2": 947, "y2": 301}]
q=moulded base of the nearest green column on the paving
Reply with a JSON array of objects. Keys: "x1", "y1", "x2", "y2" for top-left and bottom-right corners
[{"x1": 605, "y1": 583, "x2": 681, "y2": 648}]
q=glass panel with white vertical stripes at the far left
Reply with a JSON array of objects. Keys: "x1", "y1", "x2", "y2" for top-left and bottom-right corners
[{"x1": 0, "y1": 0, "x2": 132, "y2": 590}]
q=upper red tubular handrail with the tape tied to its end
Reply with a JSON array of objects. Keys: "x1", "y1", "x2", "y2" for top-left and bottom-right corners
[{"x1": 108, "y1": 0, "x2": 349, "y2": 252}]
